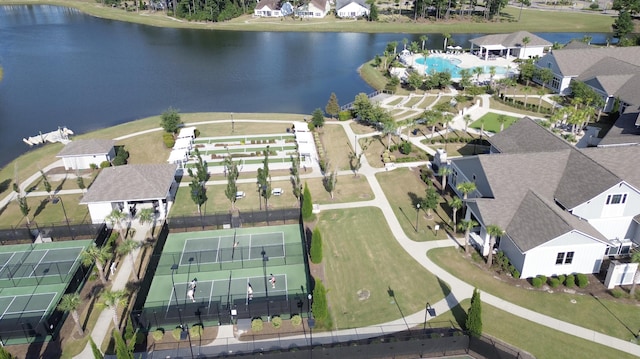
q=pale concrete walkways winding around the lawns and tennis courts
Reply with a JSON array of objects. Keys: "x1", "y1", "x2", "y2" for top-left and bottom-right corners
[{"x1": 0, "y1": 115, "x2": 640, "y2": 359}]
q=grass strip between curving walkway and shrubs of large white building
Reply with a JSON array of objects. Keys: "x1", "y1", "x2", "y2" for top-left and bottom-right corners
[{"x1": 428, "y1": 248, "x2": 640, "y2": 344}]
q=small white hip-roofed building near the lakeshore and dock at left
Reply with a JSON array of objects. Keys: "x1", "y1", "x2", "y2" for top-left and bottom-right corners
[{"x1": 56, "y1": 139, "x2": 116, "y2": 171}]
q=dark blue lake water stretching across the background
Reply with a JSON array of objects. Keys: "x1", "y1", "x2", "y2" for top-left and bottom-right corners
[{"x1": 0, "y1": 5, "x2": 610, "y2": 166}]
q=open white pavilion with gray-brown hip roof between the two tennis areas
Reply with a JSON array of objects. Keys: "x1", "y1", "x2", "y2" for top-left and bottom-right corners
[{"x1": 80, "y1": 164, "x2": 177, "y2": 223}]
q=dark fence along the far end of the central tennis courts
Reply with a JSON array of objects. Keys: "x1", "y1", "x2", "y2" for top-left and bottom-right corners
[{"x1": 167, "y1": 207, "x2": 300, "y2": 232}]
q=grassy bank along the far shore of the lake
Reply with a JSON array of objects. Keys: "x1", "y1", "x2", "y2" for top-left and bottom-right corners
[{"x1": 0, "y1": 0, "x2": 613, "y2": 34}]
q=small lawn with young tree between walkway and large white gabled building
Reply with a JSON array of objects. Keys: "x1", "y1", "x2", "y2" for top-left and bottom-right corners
[{"x1": 376, "y1": 168, "x2": 450, "y2": 241}]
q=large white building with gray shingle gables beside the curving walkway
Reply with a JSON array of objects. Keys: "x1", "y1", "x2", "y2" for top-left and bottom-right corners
[{"x1": 448, "y1": 118, "x2": 640, "y2": 277}]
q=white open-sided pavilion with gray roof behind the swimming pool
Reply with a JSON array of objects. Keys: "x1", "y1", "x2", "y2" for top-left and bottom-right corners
[{"x1": 469, "y1": 31, "x2": 553, "y2": 60}]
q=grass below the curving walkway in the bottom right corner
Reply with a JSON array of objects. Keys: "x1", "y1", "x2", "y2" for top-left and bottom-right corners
[{"x1": 434, "y1": 296, "x2": 633, "y2": 359}]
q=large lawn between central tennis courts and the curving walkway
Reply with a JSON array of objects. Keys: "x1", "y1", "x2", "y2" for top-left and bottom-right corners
[{"x1": 317, "y1": 207, "x2": 449, "y2": 329}]
